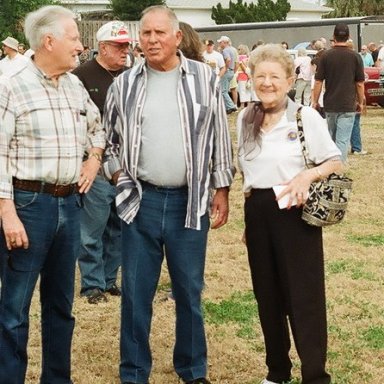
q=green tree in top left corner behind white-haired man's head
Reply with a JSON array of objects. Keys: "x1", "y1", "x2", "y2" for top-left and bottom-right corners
[{"x1": 0, "y1": 0, "x2": 57, "y2": 42}]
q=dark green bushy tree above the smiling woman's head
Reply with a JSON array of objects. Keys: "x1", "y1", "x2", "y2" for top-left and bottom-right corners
[{"x1": 211, "y1": 0, "x2": 291, "y2": 24}]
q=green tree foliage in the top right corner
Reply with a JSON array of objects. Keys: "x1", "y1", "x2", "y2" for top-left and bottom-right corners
[{"x1": 326, "y1": 0, "x2": 384, "y2": 18}]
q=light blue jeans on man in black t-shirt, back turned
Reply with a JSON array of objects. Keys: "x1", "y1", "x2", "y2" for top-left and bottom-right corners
[{"x1": 326, "y1": 112, "x2": 356, "y2": 162}]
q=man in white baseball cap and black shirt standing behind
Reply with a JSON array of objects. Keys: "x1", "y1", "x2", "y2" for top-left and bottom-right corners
[{"x1": 72, "y1": 21, "x2": 132, "y2": 304}]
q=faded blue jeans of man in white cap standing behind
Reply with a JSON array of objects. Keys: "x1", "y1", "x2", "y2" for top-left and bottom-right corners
[{"x1": 78, "y1": 176, "x2": 121, "y2": 295}]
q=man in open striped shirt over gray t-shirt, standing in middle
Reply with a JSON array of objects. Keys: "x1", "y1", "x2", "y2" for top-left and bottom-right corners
[{"x1": 104, "y1": 6, "x2": 234, "y2": 384}]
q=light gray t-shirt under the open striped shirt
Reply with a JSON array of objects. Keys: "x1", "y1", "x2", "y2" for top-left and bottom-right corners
[{"x1": 138, "y1": 66, "x2": 187, "y2": 187}]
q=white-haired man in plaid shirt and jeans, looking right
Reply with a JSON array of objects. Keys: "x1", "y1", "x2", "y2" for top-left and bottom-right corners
[{"x1": 0, "y1": 6, "x2": 105, "y2": 384}]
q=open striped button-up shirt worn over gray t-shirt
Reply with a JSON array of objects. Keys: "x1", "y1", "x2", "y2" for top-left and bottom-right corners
[{"x1": 104, "y1": 52, "x2": 235, "y2": 229}]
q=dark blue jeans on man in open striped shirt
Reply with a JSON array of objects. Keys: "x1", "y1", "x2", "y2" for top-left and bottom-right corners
[{"x1": 120, "y1": 184, "x2": 209, "y2": 383}]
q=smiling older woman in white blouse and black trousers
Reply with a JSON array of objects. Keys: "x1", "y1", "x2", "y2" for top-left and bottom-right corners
[{"x1": 238, "y1": 44, "x2": 342, "y2": 384}]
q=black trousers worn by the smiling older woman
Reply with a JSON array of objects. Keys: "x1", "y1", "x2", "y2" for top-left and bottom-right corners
[{"x1": 244, "y1": 189, "x2": 330, "y2": 384}]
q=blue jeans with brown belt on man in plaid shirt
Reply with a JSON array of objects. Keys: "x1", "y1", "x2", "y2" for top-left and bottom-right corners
[{"x1": 0, "y1": 190, "x2": 81, "y2": 384}]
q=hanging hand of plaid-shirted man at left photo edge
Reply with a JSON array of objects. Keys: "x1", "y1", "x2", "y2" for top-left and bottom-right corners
[{"x1": 0, "y1": 199, "x2": 29, "y2": 250}]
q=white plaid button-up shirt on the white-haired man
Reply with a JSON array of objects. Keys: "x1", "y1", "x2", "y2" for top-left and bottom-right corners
[{"x1": 0, "y1": 61, "x2": 105, "y2": 199}]
